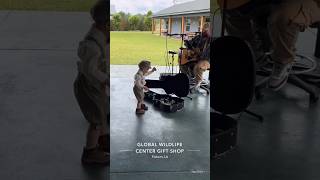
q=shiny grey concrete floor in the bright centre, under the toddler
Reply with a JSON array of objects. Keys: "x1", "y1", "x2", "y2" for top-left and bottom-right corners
[{"x1": 110, "y1": 66, "x2": 210, "y2": 180}]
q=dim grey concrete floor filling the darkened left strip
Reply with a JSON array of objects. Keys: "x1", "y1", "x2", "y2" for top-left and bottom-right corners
[{"x1": 0, "y1": 11, "x2": 109, "y2": 180}]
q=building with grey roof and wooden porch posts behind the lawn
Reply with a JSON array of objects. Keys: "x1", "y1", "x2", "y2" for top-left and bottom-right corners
[{"x1": 152, "y1": 0, "x2": 210, "y2": 35}]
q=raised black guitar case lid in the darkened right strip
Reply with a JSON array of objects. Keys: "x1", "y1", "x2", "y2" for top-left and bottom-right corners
[{"x1": 210, "y1": 36, "x2": 255, "y2": 114}]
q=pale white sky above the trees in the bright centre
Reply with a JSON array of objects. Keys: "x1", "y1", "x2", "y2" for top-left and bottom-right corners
[{"x1": 111, "y1": 0, "x2": 190, "y2": 14}]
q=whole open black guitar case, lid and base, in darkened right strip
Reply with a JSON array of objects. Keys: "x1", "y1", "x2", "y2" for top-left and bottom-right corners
[{"x1": 209, "y1": 36, "x2": 262, "y2": 157}]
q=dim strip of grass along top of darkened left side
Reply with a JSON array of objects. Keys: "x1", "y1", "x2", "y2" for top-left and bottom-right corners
[{"x1": 0, "y1": 0, "x2": 96, "y2": 11}]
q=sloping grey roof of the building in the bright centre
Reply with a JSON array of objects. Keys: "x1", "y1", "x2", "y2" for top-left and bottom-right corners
[{"x1": 153, "y1": 0, "x2": 210, "y2": 17}]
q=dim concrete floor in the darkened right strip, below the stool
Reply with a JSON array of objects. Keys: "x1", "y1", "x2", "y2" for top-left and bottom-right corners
[{"x1": 211, "y1": 15, "x2": 320, "y2": 180}]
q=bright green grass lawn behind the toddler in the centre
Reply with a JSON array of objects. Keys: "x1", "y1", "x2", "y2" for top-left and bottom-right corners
[{"x1": 110, "y1": 31, "x2": 181, "y2": 65}]
